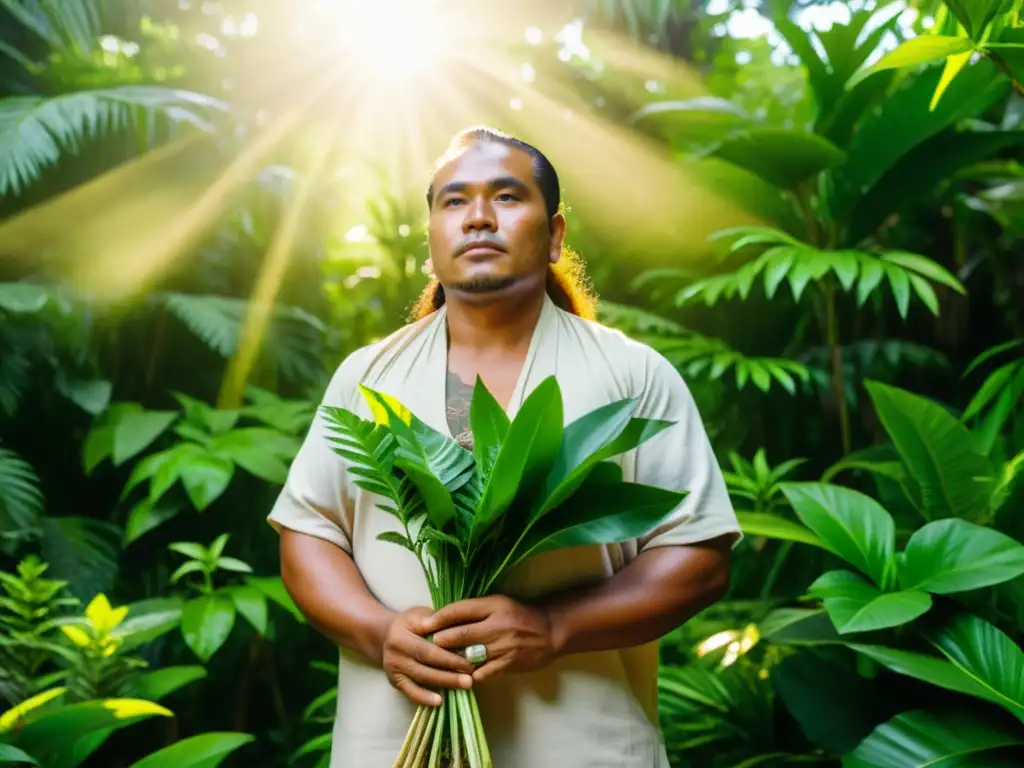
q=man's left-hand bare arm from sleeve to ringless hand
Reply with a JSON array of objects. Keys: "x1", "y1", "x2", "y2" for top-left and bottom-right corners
[{"x1": 281, "y1": 528, "x2": 473, "y2": 706}]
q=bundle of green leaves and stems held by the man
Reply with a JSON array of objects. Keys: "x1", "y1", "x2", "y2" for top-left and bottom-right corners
[{"x1": 322, "y1": 377, "x2": 685, "y2": 768}]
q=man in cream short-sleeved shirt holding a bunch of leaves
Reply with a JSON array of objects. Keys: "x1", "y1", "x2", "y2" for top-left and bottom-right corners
[{"x1": 269, "y1": 129, "x2": 740, "y2": 768}]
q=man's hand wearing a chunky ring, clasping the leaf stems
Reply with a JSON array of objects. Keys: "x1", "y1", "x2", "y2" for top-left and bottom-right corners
[{"x1": 424, "y1": 595, "x2": 558, "y2": 682}]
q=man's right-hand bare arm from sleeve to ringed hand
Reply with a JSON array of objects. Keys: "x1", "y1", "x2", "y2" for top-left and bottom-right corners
[{"x1": 425, "y1": 536, "x2": 732, "y2": 681}]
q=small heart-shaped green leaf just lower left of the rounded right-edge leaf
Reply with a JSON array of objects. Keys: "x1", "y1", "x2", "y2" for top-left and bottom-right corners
[{"x1": 808, "y1": 570, "x2": 932, "y2": 635}]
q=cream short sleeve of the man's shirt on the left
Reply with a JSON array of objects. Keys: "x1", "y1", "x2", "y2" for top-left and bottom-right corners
[{"x1": 267, "y1": 356, "x2": 358, "y2": 554}]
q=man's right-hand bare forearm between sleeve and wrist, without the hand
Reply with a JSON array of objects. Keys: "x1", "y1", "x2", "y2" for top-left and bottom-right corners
[{"x1": 540, "y1": 538, "x2": 731, "y2": 655}]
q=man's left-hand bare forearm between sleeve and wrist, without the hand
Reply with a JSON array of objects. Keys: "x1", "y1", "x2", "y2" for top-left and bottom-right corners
[{"x1": 281, "y1": 528, "x2": 394, "y2": 665}]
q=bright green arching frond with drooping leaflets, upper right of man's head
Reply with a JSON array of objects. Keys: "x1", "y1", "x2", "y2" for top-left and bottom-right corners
[{"x1": 676, "y1": 227, "x2": 966, "y2": 318}]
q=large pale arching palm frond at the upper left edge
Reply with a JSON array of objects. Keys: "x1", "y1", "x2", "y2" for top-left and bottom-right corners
[{"x1": 0, "y1": 85, "x2": 224, "y2": 195}]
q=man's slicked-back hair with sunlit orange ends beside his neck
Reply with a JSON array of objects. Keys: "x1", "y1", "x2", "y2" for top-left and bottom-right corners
[{"x1": 410, "y1": 127, "x2": 597, "y2": 321}]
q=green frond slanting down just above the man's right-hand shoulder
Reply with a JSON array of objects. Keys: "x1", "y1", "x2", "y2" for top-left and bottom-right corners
[{"x1": 600, "y1": 301, "x2": 811, "y2": 394}]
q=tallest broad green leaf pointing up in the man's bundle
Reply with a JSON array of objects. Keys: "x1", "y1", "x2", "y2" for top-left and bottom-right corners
[{"x1": 471, "y1": 376, "x2": 563, "y2": 543}]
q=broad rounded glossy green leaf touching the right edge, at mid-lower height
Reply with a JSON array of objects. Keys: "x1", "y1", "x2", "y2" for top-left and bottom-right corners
[{"x1": 900, "y1": 518, "x2": 1024, "y2": 595}]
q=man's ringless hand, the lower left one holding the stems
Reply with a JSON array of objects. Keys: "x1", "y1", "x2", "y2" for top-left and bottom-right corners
[{"x1": 382, "y1": 608, "x2": 473, "y2": 707}]
